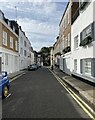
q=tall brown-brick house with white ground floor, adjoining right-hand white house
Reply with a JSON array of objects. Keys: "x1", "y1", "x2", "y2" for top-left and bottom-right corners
[{"x1": 59, "y1": 1, "x2": 72, "y2": 74}]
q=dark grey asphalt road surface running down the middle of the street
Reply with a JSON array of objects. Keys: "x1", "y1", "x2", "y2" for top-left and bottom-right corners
[{"x1": 2, "y1": 68, "x2": 88, "y2": 119}]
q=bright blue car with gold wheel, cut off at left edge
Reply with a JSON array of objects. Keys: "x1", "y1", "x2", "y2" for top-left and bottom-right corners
[{"x1": 0, "y1": 71, "x2": 10, "y2": 98}]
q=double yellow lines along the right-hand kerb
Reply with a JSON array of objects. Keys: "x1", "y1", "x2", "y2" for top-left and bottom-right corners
[{"x1": 49, "y1": 69, "x2": 95, "y2": 120}]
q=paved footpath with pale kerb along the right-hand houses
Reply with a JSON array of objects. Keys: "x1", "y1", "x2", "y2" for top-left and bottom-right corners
[{"x1": 53, "y1": 68, "x2": 95, "y2": 108}]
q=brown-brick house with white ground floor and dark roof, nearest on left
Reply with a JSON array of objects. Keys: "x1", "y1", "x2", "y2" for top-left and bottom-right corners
[{"x1": 0, "y1": 11, "x2": 19, "y2": 73}]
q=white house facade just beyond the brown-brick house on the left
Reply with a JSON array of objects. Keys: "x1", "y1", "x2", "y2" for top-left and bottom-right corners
[{"x1": 19, "y1": 27, "x2": 31, "y2": 70}]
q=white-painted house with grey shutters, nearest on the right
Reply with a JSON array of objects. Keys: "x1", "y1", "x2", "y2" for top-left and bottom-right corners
[{"x1": 71, "y1": 0, "x2": 95, "y2": 83}]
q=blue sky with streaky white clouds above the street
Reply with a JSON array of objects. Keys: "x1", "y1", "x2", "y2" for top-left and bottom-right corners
[{"x1": 0, "y1": 0, "x2": 68, "y2": 51}]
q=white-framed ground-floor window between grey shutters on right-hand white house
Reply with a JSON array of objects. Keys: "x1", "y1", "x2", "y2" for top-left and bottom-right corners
[{"x1": 84, "y1": 59, "x2": 91, "y2": 75}]
